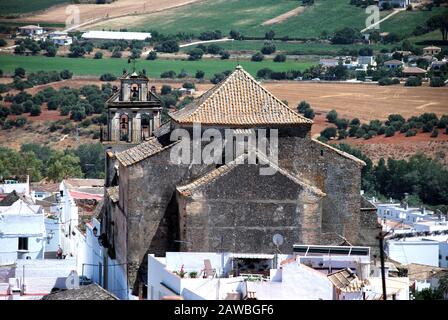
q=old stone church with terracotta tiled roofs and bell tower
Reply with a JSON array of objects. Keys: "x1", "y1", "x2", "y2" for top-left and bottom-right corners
[{"x1": 101, "y1": 66, "x2": 379, "y2": 295}]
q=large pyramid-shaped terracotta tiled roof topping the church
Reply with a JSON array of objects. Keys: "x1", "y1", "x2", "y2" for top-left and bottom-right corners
[{"x1": 170, "y1": 66, "x2": 313, "y2": 126}]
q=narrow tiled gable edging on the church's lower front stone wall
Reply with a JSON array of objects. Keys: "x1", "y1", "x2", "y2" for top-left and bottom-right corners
[{"x1": 177, "y1": 153, "x2": 326, "y2": 197}]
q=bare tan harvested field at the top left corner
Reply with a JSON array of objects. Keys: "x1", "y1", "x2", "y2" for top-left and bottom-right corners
[{"x1": 8, "y1": 0, "x2": 203, "y2": 23}]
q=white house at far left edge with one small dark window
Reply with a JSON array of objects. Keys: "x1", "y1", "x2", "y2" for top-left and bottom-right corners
[{"x1": 0, "y1": 199, "x2": 46, "y2": 264}]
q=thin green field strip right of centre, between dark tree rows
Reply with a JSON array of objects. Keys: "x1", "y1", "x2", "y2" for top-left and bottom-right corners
[{"x1": 203, "y1": 40, "x2": 393, "y2": 55}]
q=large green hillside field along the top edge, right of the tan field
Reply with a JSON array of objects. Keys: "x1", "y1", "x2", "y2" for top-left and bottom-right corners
[{"x1": 95, "y1": 0, "x2": 446, "y2": 39}]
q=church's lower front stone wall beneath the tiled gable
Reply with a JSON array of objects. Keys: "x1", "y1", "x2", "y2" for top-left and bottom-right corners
[{"x1": 178, "y1": 165, "x2": 322, "y2": 253}]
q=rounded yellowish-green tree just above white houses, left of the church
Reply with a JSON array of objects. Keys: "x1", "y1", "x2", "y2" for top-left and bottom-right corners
[{"x1": 48, "y1": 151, "x2": 84, "y2": 182}]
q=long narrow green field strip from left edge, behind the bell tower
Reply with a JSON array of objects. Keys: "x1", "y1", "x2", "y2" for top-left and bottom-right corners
[{"x1": 0, "y1": 55, "x2": 317, "y2": 78}]
